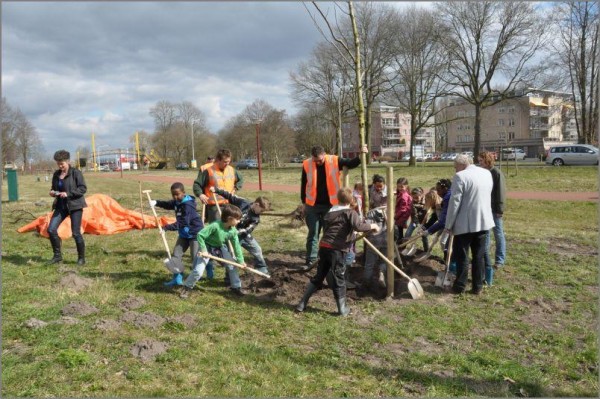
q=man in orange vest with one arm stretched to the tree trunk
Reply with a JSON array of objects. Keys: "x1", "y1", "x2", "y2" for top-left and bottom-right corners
[{"x1": 300, "y1": 145, "x2": 368, "y2": 266}]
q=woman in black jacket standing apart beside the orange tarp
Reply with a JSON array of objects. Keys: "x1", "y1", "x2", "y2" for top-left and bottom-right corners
[{"x1": 48, "y1": 150, "x2": 87, "y2": 266}]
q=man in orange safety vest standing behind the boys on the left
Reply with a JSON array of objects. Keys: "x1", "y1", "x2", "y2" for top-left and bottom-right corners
[{"x1": 194, "y1": 149, "x2": 243, "y2": 223}]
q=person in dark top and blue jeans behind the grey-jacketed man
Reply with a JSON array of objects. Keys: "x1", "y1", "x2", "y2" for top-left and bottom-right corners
[{"x1": 479, "y1": 151, "x2": 506, "y2": 286}]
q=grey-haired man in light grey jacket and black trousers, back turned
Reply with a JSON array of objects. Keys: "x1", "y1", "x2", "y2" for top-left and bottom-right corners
[{"x1": 446, "y1": 154, "x2": 494, "y2": 295}]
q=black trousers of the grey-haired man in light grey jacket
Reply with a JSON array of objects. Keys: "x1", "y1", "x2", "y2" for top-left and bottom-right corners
[{"x1": 452, "y1": 230, "x2": 487, "y2": 292}]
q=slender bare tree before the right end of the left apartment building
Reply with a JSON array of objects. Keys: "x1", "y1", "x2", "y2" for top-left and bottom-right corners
[{"x1": 389, "y1": 6, "x2": 448, "y2": 165}]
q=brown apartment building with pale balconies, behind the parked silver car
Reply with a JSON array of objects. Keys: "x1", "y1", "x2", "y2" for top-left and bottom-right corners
[{"x1": 446, "y1": 90, "x2": 577, "y2": 157}]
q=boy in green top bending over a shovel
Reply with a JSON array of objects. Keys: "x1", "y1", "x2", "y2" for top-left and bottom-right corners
[{"x1": 179, "y1": 204, "x2": 244, "y2": 299}]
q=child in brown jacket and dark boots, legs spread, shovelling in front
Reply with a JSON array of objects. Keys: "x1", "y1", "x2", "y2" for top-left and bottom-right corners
[{"x1": 296, "y1": 187, "x2": 378, "y2": 316}]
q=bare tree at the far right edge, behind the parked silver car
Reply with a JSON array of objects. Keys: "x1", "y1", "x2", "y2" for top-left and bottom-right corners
[{"x1": 553, "y1": 1, "x2": 600, "y2": 144}]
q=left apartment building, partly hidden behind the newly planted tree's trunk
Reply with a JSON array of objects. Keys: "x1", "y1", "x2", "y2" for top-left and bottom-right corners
[{"x1": 342, "y1": 105, "x2": 435, "y2": 159}]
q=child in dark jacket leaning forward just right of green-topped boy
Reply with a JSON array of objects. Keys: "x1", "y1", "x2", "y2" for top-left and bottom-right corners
[{"x1": 210, "y1": 187, "x2": 270, "y2": 274}]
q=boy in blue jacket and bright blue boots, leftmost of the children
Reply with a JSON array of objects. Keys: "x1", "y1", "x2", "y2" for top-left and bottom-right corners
[{"x1": 152, "y1": 182, "x2": 204, "y2": 287}]
